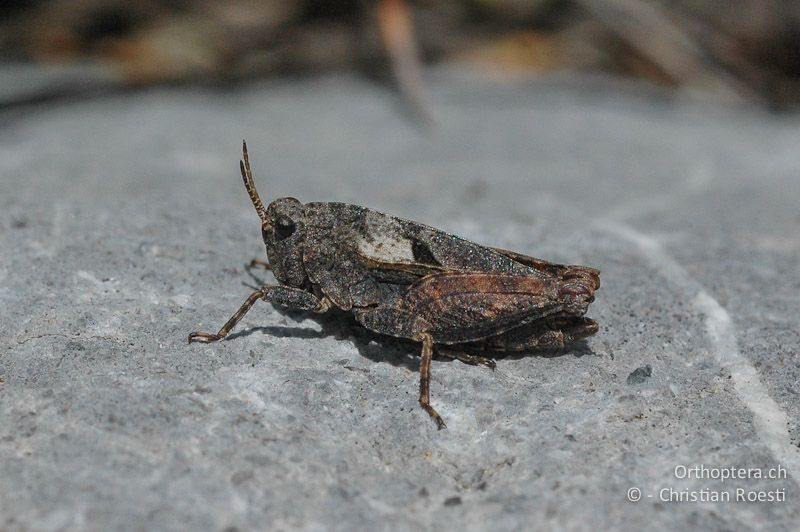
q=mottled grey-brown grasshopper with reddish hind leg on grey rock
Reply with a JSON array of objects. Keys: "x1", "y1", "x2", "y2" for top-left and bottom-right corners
[{"x1": 189, "y1": 143, "x2": 600, "y2": 429}]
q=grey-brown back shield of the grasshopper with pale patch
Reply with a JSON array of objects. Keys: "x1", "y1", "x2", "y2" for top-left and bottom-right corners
[{"x1": 303, "y1": 202, "x2": 568, "y2": 310}]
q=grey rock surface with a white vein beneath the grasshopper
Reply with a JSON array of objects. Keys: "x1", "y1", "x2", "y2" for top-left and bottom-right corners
[{"x1": 0, "y1": 68, "x2": 800, "y2": 530}]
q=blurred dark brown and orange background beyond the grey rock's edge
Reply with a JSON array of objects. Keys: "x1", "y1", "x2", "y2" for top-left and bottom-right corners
[{"x1": 0, "y1": 0, "x2": 800, "y2": 112}]
